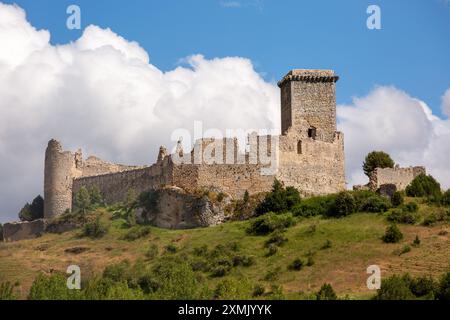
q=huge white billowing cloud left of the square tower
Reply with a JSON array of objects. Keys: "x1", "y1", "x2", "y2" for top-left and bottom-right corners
[{"x1": 0, "y1": 4, "x2": 279, "y2": 220}]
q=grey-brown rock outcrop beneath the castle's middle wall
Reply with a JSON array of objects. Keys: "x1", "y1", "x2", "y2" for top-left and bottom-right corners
[{"x1": 136, "y1": 187, "x2": 230, "y2": 229}]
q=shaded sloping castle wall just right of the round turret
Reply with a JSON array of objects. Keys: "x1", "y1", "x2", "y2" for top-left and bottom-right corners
[{"x1": 73, "y1": 158, "x2": 172, "y2": 204}]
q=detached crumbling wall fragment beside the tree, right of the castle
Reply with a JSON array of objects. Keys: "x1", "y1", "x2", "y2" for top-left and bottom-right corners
[{"x1": 369, "y1": 166, "x2": 426, "y2": 190}]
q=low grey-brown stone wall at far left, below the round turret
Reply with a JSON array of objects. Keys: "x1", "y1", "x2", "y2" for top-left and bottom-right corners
[{"x1": 3, "y1": 219, "x2": 46, "y2": 242}]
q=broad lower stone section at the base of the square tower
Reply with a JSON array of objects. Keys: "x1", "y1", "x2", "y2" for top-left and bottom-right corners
[{"x1": 277, "y1": 133, "x2": 345, "y2": 196}]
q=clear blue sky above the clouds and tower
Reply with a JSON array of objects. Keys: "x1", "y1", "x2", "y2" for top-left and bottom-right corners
[{"x1": 3, "y1": 0, "x2": 450, "y2": 116}]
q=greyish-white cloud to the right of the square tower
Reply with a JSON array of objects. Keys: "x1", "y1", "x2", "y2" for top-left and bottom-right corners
[{"x1": 338, "y1": 86, "x2": 450, "y2": 188}]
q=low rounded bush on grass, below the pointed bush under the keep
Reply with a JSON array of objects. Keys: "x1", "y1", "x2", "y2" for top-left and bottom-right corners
[{"x1": 247, "y1": 212, "x2": 294, "y2": 235}]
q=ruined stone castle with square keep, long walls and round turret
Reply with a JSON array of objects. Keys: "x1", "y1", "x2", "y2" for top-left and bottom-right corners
[{"x1": 44, "y1": 69, "x2": 345, "y2": 218}]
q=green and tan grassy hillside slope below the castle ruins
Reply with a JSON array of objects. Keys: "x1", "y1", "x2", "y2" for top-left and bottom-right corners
[{"x1": 0, "y1": 195, "x2": 450, "y2": 299}]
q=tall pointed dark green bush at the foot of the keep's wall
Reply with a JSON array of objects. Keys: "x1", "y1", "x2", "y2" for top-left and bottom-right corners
[{"x1": 256, "y1": 179, "x2": 300, "y2": 215}]
